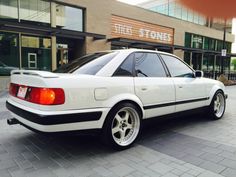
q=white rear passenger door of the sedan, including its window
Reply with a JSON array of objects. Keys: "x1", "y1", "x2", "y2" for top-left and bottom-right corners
[{"x1": 134, "y1": 52, "x2": 175, "y2": 118}]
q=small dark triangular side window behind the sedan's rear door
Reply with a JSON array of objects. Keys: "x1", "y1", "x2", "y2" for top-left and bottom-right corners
[{"x1": 113, "y1": 54, "x2": 134, "y2": 77}]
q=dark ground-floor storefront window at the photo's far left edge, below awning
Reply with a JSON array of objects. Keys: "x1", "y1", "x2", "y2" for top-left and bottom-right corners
[{"x1": 0, "y1": 32, "x2": 20, "y2": 76}]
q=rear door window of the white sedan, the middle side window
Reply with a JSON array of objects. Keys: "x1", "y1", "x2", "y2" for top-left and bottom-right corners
[{"x1": 135, "y1": 52, "x2": 166, "y2": 77}]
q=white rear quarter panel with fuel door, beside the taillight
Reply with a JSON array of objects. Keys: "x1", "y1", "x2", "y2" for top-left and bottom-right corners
[{"x1": 38, "y1": 75, "x2": 134, "y2": 111}]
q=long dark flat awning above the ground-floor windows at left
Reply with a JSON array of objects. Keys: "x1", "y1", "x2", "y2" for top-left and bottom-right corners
[{"x1": 0, "y1": 20, "x2": 106, "y2": 40}]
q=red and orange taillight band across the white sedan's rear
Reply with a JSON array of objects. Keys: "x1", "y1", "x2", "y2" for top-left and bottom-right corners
[{"x1": 9, "y1": 83, "x2": 65, "y2": 105}]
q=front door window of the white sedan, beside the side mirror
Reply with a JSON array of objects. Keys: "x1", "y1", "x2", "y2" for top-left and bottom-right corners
[{"x1": 161, "y1": 54, "x2": 193, "y2": 77}]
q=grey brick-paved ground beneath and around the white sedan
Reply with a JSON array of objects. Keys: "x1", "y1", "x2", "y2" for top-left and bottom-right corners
[{"x1": 0, "y1": 86, "x2": 236, "y2": 177}]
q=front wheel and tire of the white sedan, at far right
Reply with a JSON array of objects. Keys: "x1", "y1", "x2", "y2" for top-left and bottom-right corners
[{"x1": 208, "y1": 90, "x2": 226, "y2": 120}]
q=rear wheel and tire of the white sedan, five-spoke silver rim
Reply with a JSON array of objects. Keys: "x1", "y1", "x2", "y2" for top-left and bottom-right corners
[{"x1": 102, "y1": 103, "x2": 141, "y2": 150}]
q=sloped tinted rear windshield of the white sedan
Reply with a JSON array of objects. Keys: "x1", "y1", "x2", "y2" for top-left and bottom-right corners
[{"x1": 53, "y1": 52, "x2": 117, "y2": 75}]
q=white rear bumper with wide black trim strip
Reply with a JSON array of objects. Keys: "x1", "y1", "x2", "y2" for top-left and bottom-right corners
[{"x1": 6, "y1": 101, "x2": 108, "y2": 132}]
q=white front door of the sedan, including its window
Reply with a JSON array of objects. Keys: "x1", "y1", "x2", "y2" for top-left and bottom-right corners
[{"x1": 161, "y1": 54, "x2": 208, "y2": 112}]
